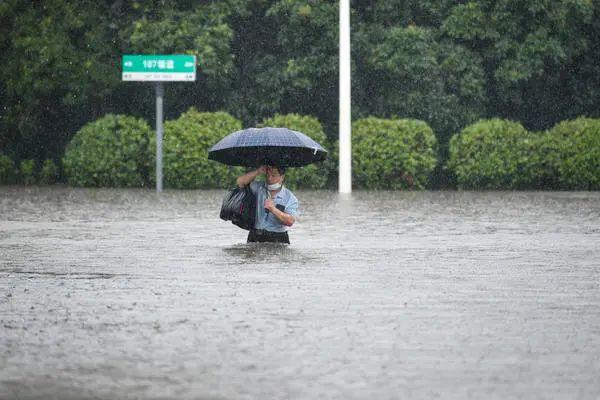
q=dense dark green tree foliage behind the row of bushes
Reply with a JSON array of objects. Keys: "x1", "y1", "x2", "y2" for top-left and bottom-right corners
[{"x1": 0, "y1": 0, "x2": 600, "y2": 188}]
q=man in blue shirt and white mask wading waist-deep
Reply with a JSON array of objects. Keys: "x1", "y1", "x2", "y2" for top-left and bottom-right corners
[{"x1": 236, "y1": 165, "x2": 298, "y2": 244}]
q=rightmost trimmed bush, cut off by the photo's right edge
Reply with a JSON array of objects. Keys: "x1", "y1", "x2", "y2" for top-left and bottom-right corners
[{"x1": 548, "y1": 117, "x2": 600, "y2": 190}]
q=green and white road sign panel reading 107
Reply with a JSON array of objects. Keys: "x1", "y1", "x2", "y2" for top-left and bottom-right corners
[{"x1": 123, "y1": 54, "x2": 196, "y2": 82}]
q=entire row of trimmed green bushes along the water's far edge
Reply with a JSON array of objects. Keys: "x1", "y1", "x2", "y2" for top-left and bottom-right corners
[{"x1": 55, "y1": 109, "x2": 600, "y2": 190}]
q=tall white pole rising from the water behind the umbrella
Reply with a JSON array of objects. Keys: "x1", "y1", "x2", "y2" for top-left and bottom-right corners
[{"x1": 338, "y1": 0, "x2": 352, "y2": 193}]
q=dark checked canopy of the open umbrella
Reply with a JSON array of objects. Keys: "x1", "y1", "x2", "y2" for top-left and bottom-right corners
[{"x1": 208, "y1": 127, "x2": 327, "y2": 167}]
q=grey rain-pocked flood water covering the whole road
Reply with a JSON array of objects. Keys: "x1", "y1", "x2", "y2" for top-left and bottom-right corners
[{"x1": 0, "y1": 187, "x2": 600, "y2": 399}]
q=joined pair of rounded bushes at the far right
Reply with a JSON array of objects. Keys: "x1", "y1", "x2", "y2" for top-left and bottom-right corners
[{"x1": 448, "y1": 118, "x2": 600, "y2": 190}]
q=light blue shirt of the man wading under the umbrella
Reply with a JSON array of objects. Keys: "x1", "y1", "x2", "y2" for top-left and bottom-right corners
[{"x1": 250, "y1": 182, "x2": 298, "y2": 232}]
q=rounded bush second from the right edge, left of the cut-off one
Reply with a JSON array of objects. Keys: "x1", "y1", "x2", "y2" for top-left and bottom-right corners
[{"x1": 448, "y1": 118, "x2": 545, "y2": 189}]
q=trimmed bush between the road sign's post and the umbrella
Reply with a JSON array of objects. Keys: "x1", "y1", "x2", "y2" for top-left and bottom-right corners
[{"x1": 150, "y1": 108, "x2": 243, "y2": 189}]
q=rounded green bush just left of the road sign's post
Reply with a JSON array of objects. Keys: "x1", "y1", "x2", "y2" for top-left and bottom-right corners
[{"x1": 63, "y1": 114, "x2": 152, "y2": 187}]
